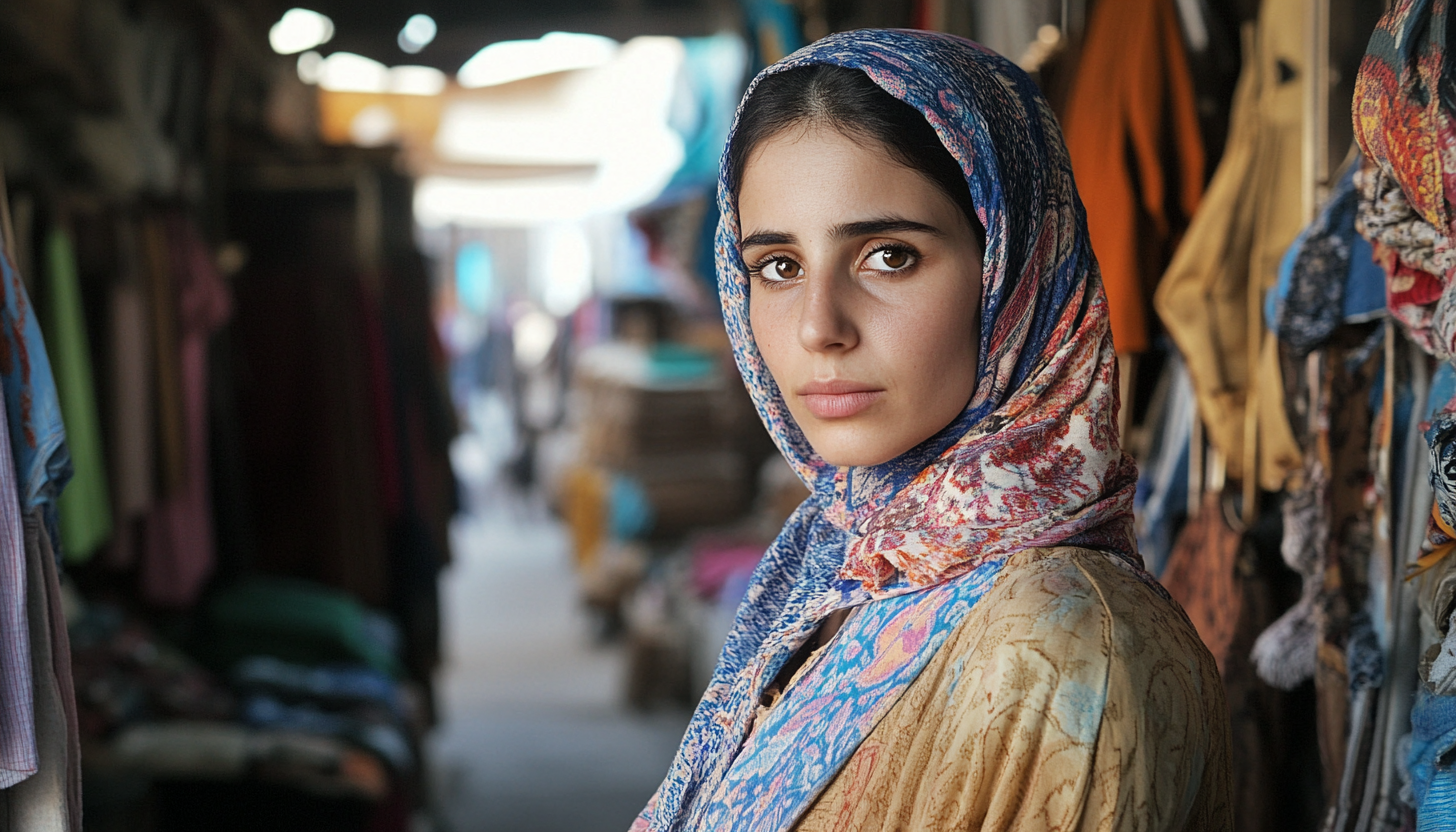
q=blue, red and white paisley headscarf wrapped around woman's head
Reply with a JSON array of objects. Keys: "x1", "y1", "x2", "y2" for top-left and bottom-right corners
[{"x1": 633, "y1": 31, "x2": 1140, "y2": 829}]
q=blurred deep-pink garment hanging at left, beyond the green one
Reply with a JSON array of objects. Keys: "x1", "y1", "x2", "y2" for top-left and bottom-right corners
[{"x1": 141, "y1": 217, "x2": 233, "y2": 608}]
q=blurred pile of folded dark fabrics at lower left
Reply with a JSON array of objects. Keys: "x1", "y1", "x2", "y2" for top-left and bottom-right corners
[{"x1": 71, "y1": 580, "x2": 427, "y2": 827}]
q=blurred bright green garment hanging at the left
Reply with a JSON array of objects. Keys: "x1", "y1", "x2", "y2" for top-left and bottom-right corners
[{"x1": 42, "y1": 227, "x2": 112, "y2": 562}]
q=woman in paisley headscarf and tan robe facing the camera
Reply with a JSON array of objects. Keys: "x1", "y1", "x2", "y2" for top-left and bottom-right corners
[{"x1": 633, "y1": 31, "x2": 1230, "y2": 832}]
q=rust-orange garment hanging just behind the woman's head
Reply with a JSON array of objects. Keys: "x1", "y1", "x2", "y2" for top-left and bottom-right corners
[{"x1": 1061, "y1": 0, "x2": 1204, "y2": 353}]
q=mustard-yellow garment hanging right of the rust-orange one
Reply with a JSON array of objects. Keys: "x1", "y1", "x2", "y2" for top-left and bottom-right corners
[{"x1": 1153, "y1": 0, "x2": 1305, "y2": 491}]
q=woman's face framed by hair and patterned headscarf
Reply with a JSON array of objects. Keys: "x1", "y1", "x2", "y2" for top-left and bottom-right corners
[{"x1": 738, "y1": 125, "x2": 981, "y2": 465}]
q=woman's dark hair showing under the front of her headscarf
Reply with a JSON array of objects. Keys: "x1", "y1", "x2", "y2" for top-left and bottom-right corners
[{"x1": 728, "y1": 64, "x2": 986, "y2": 248}]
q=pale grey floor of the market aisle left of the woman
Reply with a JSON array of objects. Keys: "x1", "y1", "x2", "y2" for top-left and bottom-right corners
[{"x1": 432, "y1": 495, "x2": 687, "y2": 832}]
